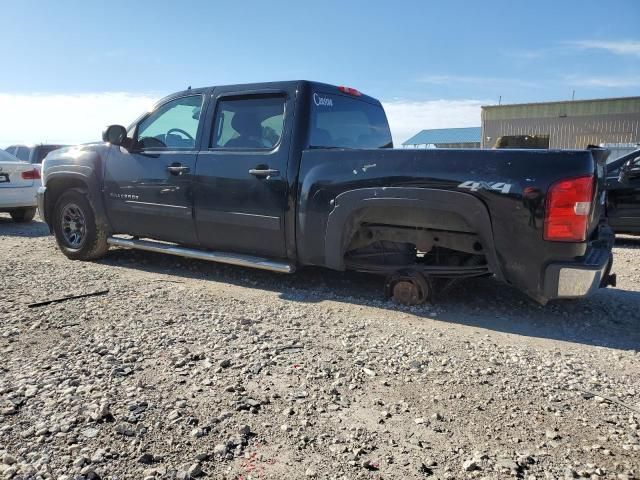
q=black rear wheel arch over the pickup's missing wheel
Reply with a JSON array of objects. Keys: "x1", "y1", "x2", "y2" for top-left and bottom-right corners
[{"x1": 324, "y1": 187, "x2": 504, "y2": 280}]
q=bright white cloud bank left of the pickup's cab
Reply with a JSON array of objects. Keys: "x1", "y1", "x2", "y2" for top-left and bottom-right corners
[{"x1": 0, "y1": 92, "x2": 161, "y2": 148}]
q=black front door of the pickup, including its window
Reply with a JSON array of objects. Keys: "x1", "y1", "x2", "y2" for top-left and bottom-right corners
[{"x1": 104, "y1": 95, "x2": 204, "y2": 245}]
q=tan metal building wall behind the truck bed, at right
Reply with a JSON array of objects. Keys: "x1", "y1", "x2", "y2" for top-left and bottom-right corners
[{"x1": 482, "y1": 97, "x2": 640, "y2": 148}]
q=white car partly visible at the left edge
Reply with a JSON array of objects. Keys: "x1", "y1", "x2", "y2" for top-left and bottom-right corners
[{"x1": 0, "y1": 150, "x2": 41, "y2": 222}]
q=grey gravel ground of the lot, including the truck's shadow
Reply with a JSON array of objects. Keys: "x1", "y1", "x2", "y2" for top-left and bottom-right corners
[{"x1": 0, "y1": 216, "x2": 640, "y2": 480}]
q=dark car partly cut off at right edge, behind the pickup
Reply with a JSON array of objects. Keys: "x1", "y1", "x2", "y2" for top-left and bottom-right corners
[{"x1": 607, "y1": 150, "x2": 640, "y2": 234}]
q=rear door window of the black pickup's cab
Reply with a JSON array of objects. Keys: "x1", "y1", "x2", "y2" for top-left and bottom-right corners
[{"x1": 210, "y1": 95, "x2": 285, "y2": 150}]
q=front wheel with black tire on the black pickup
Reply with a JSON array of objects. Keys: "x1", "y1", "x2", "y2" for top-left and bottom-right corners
[{"x1": 53, "y1": 188, "x2": 109, "y2": 260}]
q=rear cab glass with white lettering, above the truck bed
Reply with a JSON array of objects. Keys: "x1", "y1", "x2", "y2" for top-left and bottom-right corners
[{"x1": 309, "y1": 92, "x2": 393, "y2": 148}]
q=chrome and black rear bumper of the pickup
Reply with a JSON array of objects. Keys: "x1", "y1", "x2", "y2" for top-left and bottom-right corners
[{"x1": 543, "y1": 225, "x2": 615, "y2": 300}]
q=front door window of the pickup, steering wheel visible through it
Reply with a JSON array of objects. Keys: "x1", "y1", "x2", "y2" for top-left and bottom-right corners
[{"x1": 136, "y1": 95, "x2": 203, "y2": 150}]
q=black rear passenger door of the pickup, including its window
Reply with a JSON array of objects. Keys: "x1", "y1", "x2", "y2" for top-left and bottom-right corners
[{"x1": 194, "y1": 87, "x2": 295, "y2": 258}]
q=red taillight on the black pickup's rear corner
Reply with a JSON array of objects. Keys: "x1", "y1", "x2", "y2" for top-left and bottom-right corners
[{"x1": 544, "y1": 175, "x2": 594, "y2": 242}]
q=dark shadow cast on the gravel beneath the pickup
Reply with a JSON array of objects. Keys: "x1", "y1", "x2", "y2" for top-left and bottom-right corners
[{"x1": 101, "y1": 249, "x2": 640, "y2": 350}]
